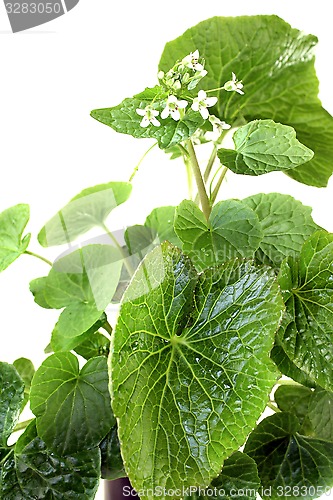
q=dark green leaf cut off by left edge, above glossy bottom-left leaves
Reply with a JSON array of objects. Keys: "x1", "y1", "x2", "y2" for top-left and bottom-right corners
[{"x1": 0, "y1": 362, "x2": 24, "y2": 448}]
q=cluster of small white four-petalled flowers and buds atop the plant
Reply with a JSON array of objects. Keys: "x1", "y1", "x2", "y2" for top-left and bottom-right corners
[{"x1": 136, "y1": 50, "x2": 244, "y2": 133}]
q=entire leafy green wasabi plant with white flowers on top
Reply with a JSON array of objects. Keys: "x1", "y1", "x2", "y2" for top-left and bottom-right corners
[{"x1": 0, "y1": 16, "x2": 333, "y2": 500}]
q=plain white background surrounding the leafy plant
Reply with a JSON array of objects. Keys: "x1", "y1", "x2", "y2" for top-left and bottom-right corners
[{"x1": 0, "y1": 0, "x2": 333, "y2": 496}]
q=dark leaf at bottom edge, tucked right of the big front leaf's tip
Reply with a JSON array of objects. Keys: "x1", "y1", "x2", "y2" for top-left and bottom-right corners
[{"x1": 185, "y1": 451, "x2": 260, "y2": 500}]
